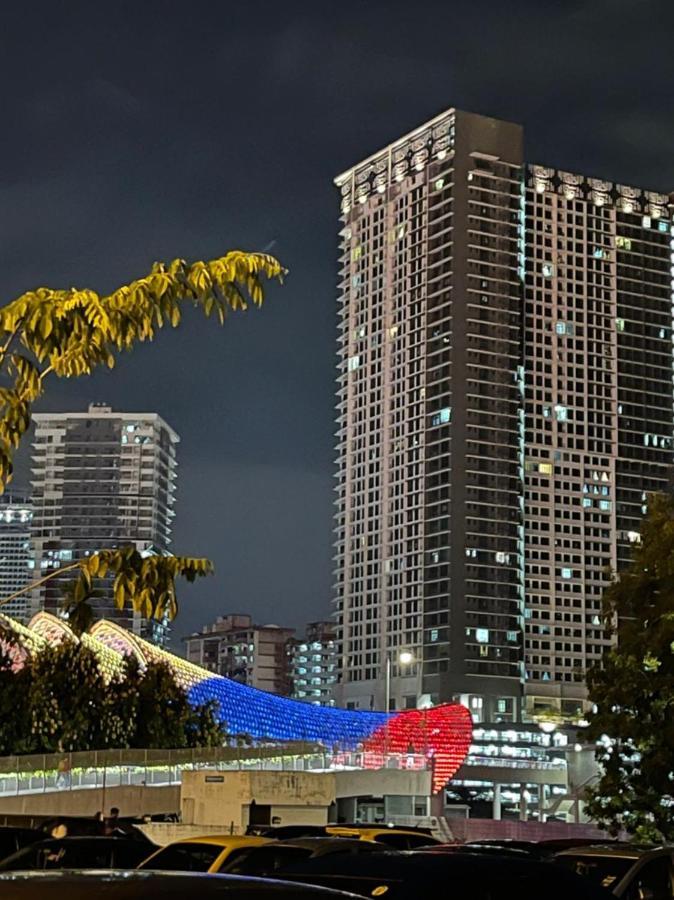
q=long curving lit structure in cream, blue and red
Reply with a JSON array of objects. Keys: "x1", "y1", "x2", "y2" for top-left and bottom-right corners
[{"x1": 0, "y1": 612, "x2": 472, "y2": 791}]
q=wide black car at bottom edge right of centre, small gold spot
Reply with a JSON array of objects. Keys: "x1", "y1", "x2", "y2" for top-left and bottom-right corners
[{"x1": 283, "y1": 852, "x2": 607, "y2": 900}]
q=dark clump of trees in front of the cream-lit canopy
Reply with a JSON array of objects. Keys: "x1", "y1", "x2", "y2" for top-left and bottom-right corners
[{"x1": 0, "y1": 641, "x2": 225, "y2": 755}]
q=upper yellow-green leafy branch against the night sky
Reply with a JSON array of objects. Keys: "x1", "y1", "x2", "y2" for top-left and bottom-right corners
[{"x1": 0, "y1": 250, "x2": 284, "y2": 491}]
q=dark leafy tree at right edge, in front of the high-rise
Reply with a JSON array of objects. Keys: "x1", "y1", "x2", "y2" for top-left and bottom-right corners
[{"x1": 587, "y1": 495, "x2": 674, "y2": 841}]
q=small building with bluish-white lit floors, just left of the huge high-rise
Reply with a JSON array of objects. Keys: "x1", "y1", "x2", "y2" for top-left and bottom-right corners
[{"x1": 289, "y1": 622, "x2": 337, "y2": 706}]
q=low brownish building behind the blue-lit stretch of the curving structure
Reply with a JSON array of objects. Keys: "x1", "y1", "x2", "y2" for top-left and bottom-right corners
[{"x1": 183, "y1": 614, "x2": 295, "y2": 696}]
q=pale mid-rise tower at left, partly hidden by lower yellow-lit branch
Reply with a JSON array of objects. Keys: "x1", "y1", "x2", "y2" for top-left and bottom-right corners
[{"x1": 31, "y1": 404, "x2": 179, "y2": 639}]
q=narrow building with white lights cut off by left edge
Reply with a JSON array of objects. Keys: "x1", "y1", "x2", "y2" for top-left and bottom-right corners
[{"x1": 0, "y1": 488, "x2": 33, "y2": 622}]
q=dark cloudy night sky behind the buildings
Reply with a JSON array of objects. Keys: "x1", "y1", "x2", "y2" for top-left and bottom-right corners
[{"x1": 0, "y1": 0, "x2": 674, "y2": 637}]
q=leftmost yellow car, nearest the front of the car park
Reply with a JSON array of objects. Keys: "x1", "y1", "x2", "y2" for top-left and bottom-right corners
[{"x1": 138, "y1": 834, "x2": 270, "y2": 872}]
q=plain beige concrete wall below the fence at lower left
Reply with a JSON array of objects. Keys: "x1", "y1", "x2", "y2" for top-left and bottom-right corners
[{"x1": 0, "y1": 785, "x2": 180, "y2": 816}]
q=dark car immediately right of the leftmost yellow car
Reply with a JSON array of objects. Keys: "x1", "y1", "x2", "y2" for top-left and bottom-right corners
[{"x1": 220, "y1": 837, "x2": 382, "y2": 875}]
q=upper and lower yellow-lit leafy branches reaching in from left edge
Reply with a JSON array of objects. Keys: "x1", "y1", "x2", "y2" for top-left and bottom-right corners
[{"x1": 0, "y1": 251, "x2": 285, "y2": 631}]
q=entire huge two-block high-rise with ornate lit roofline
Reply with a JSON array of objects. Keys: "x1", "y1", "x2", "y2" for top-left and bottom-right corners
[{"x1": 335, "y1": 110, "x2": 673, "y2": 720}]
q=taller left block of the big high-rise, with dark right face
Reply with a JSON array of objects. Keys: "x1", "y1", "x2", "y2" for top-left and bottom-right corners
[{"x1": 336, "y1": 110, "x2": 524, "y2": 712}]
